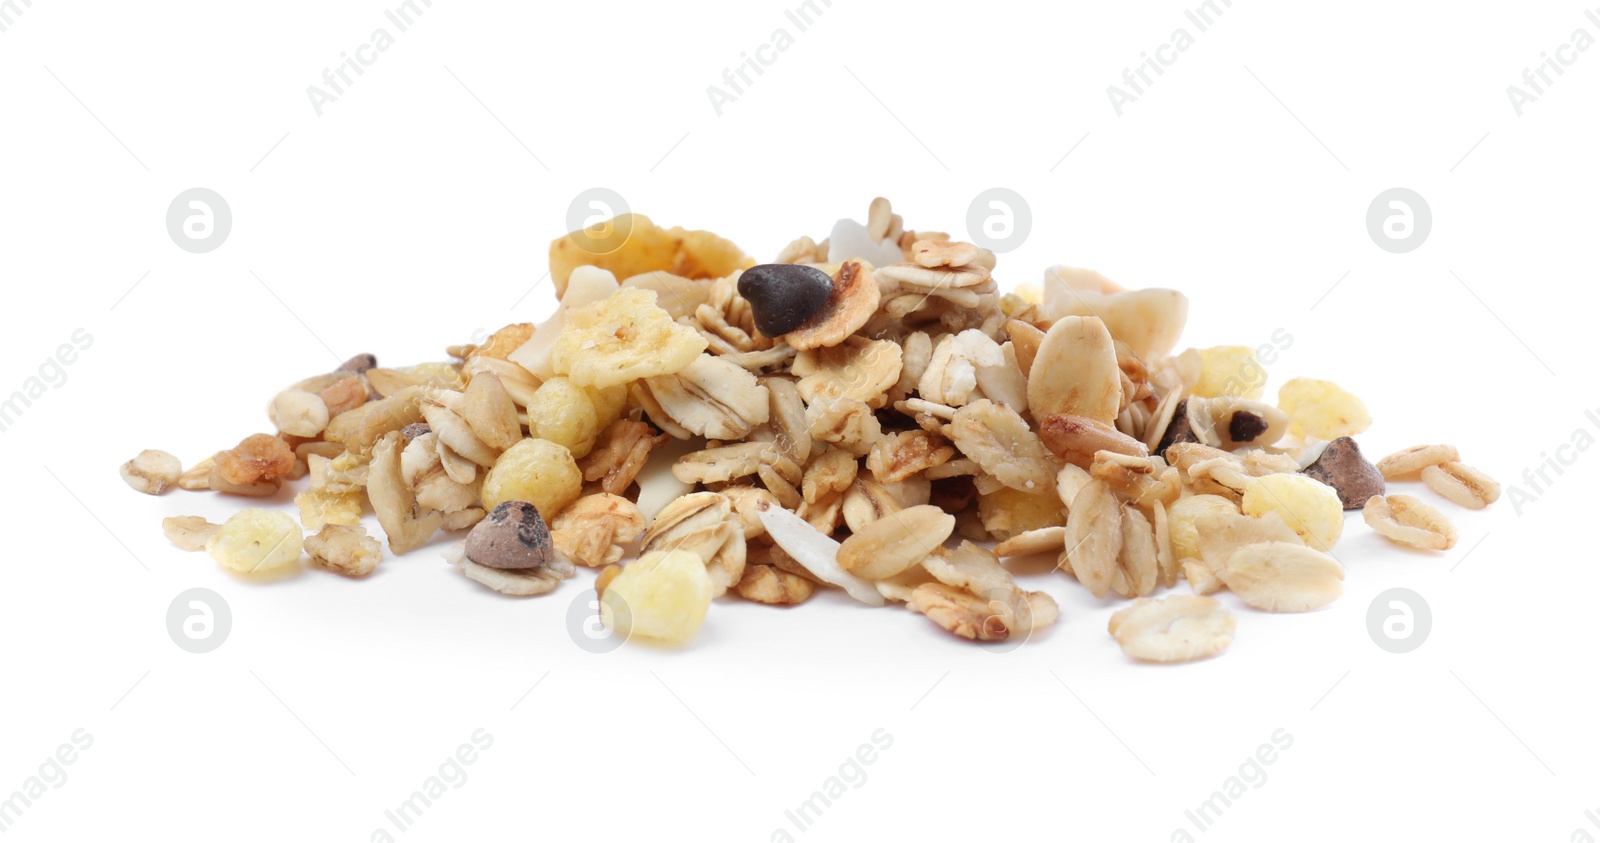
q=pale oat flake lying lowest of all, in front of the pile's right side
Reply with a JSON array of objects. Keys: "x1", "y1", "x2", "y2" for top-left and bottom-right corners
[{"x1": 1107, "y1": 595, "x2": 1234, "y2": 664}]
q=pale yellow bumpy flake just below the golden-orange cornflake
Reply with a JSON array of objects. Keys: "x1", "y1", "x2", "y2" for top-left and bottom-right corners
[{"x1": 550, "y1": 288, "x2": 707, "y2": 389}]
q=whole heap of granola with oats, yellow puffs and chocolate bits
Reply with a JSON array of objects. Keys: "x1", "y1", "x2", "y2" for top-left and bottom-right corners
[{"x1": 122, "y1": 198, "x2": 1499, "y2": 662}]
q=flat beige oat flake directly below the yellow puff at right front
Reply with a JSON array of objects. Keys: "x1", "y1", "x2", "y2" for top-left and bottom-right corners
[{"x1": 1218, "y1": 542, "x2": 1344, "y2": 611}]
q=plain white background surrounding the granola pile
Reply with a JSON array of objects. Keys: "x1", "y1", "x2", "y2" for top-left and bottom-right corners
[{"x1": 0, "y1": 0, "x2": 1600, "y2": 841}]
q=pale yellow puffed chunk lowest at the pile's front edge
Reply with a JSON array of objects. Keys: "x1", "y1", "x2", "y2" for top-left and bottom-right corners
[{"x1": 600, "y1": 550, "x2": 712, "y2": 645}]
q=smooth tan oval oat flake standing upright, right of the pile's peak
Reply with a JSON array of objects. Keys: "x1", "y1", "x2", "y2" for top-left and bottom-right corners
[{"x1": 1027, "y1": 317, "x2": 1122, "y2": 427}]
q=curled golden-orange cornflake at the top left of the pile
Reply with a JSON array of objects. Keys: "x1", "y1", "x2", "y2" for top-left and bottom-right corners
[{"x1": 550, "y1": 214, "x2": 755, "y2": 298}]
